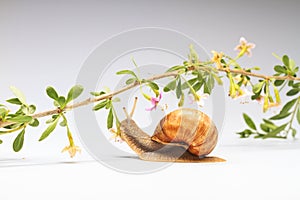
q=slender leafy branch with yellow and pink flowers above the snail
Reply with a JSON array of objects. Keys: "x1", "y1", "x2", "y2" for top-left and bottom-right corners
[{"x1": 0, "y1": 38, "x2": 300, "y2": 157}]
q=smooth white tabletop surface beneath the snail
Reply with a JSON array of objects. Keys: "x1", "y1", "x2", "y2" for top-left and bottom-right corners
[{"x1": 0, "y1": 140, "x2": 300, "y2": 200}]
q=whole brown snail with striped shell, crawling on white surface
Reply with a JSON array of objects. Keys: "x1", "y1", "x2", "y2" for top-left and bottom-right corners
[{"x1": 120, "y1": 98, "x2": 225, "y2": 162}]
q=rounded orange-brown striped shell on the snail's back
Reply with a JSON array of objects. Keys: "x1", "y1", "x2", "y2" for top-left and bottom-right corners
[{"x1": 151, "y1": 108, "x2": 218, "y2": 157}]
